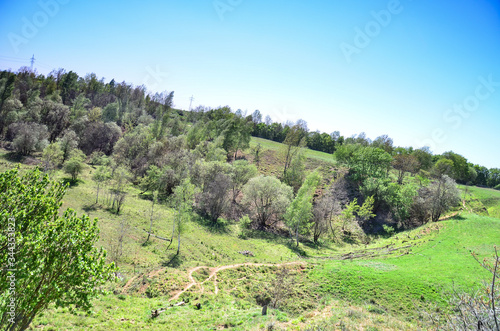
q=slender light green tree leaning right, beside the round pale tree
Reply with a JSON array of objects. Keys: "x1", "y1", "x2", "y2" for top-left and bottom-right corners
[{"x1": 284, "y1": 171, "x2": 321, "y2": 247}]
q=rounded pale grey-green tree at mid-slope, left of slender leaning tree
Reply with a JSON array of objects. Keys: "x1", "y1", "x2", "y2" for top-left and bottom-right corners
[{"x1": 242, "y1": 176, "x2": 293, "y2": 229}]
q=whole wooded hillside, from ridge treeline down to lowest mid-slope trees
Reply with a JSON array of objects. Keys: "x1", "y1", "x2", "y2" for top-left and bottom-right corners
[{"x1": 0, "y1": 68, "x2": 500, "y2": 243}]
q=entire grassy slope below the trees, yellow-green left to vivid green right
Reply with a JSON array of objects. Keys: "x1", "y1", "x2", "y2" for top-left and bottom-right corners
[{"x1": 0, "y1": 149, "x2": 500, "y2": 330}]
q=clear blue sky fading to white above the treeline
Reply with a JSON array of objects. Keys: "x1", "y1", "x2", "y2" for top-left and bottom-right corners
[{"x1": 0, "y1": 0, "x2": 500, "y2": 168}]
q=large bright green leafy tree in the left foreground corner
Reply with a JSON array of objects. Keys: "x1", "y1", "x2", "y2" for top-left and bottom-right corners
[{"x1": 0, "y1": 169, "x2": 115, "y2": 330}]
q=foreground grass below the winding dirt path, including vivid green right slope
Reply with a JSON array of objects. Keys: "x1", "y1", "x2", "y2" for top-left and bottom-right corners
[{"x1": 34, "y1": 214, "x2": 500, "y2": 330}]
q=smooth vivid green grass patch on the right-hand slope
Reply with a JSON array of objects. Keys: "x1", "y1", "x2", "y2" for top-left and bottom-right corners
[{"x1": 314, "y1": 214, "x2": 500, "y2": 315}]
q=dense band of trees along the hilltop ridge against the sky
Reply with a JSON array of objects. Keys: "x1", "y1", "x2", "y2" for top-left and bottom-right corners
[{"x1": 0, "y1": 67, "x2": 500, "y2": 188}]
